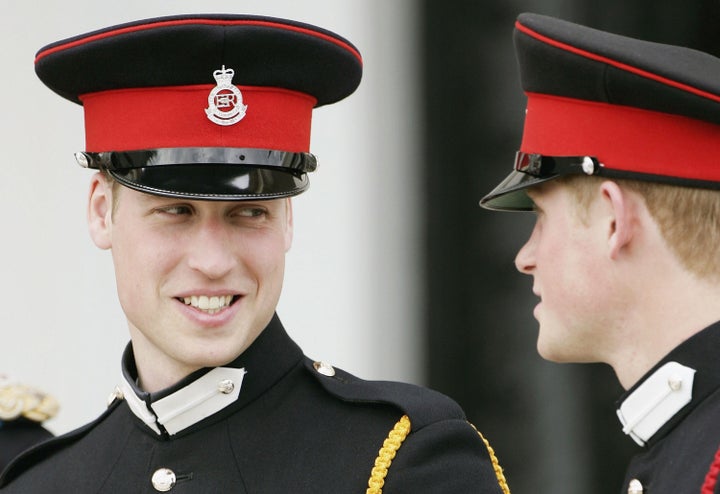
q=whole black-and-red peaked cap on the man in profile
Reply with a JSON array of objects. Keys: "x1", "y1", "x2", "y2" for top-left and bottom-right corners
[{"x1": 480, "y1": 14, "x2": 720, "y2": 210}]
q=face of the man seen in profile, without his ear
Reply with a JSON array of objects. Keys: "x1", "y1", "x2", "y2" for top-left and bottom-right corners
[{"x1": 515, "y1": 181, "x2": 612, "y2": 362}]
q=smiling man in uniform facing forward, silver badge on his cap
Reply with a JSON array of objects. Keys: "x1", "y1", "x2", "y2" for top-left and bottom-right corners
[{"x1": 0, "y1": 15, "x2": 508, "y2": 494}]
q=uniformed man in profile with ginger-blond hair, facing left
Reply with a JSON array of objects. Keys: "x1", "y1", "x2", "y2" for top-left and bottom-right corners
[{"x1": 480, "y1": 14, "x2": 720, "y2": 494}]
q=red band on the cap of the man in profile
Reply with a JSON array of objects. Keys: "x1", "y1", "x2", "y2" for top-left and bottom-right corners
[{"x1": 520, "y1": 93, "x2": 720, "y2": 181}]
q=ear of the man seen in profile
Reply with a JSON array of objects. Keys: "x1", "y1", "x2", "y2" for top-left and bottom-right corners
[{"x1": 600, "y1": 181, "x2": 637, "y2": 259}]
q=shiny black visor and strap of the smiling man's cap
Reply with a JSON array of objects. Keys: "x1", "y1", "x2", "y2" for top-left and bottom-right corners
[{"x1": 76, "y1": 148, "x2": 317, "y2": 201}]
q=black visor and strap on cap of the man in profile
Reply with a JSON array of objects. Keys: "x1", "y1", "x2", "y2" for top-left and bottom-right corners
[{"x1": 480, "y1": 152, "x2": 602, "y2": 211}]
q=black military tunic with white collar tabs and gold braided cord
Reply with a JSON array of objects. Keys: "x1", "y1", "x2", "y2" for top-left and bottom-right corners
[{"x1": 0, "y1": 317, "x2": 506, "y2": 494}]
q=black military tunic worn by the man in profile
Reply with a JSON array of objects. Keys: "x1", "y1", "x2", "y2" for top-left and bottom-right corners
[{"x1": 620, "y1": 322, "x2": 720, "y2": 494}]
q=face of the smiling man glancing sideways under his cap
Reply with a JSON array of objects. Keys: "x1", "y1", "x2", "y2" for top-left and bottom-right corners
[{"x1": 90, "y1": 179, "x2": 292, "y2": 384}]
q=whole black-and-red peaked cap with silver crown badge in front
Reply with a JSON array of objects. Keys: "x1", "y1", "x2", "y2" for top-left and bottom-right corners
[{"x1": 35, "y1": 14, "x2": 362, "y2": 200}]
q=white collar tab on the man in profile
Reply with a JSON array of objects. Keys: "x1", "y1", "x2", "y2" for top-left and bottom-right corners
[{"x1": 617, "y1": 362, "x2": 695, "y2": 446}]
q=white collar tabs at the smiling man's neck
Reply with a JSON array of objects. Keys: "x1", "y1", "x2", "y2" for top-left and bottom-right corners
[{"x1": 119, "y1": 367, "x2": 245, "y2": 436}]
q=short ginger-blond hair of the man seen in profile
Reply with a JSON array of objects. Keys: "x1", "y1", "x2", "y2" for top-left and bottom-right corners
[{"x1": 559, "y1": 175, "x2": 720, "y2": 281}]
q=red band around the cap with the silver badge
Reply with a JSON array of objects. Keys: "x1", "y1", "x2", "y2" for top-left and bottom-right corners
[{"x1": 80, "y1": 84, "x2": 316, "y2": 153}]
